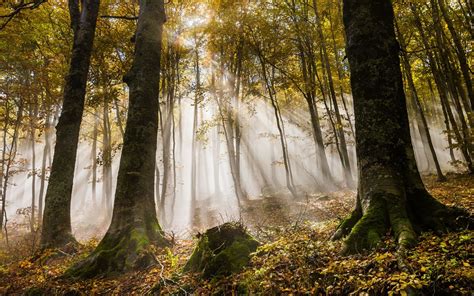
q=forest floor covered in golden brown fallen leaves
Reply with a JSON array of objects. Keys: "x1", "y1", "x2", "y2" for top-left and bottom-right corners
[{"x1": 0, "y1": 174, "x2": 474, "y2": 295}]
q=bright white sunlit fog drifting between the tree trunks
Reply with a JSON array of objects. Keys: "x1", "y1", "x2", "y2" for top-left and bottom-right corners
[{"x1": 7, "y1": 92, "x2": 458, "y2": 240}]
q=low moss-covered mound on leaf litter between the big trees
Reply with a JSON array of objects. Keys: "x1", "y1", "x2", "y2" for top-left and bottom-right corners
[{"x1": 184, "y1": 223, "x2": 259, "y2": 278}]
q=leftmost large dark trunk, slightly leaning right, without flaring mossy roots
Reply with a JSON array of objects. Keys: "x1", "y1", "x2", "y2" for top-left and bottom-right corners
[{"x1": 41, "y1": 0, "x2": 99, "y2": 248}]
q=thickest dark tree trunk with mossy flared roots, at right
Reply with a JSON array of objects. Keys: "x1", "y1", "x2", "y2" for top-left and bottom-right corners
[{"x1": 334, "y1": 0, "x2": 470, "y2": 253}]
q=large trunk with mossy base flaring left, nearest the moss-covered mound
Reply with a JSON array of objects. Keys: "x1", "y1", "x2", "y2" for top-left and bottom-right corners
[{"x1": 66, "y1": 0, "x2": 167, "y2": 277}]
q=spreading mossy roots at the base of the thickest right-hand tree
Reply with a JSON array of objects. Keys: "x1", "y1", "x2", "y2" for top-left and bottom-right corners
[{"x1": 332, "y1": 191, "x2": 474, "y2": 256}]
